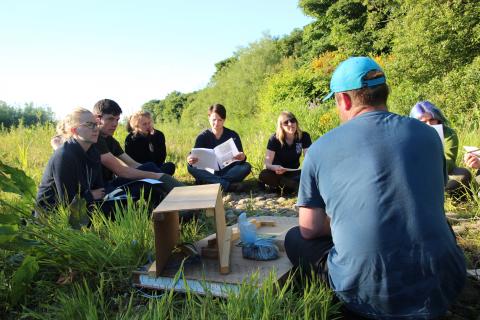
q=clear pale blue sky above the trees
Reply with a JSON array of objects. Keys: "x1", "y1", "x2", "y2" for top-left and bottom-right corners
[{"x1": 0, "y1": 0, "x2": 312, "y2": 118}]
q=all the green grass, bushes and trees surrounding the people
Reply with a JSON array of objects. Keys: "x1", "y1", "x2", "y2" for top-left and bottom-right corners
[{"x1": 0, "y1": 0, "x2": 480, "y2": 319}]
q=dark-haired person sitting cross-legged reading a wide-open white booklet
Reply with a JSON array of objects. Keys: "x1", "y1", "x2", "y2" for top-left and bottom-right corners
[{"x1": 187, "y1": 104, "x2": 251, "y2": 192}]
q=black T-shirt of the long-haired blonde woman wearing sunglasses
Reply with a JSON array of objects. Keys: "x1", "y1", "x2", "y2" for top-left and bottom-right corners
[{"x1": 267, "y1": 132, "x2": 312, "y2": 169}]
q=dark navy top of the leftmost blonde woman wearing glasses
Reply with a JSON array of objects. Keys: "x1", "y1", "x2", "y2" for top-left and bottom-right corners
[{"x1": 37, "y1": 138, "x2": 103, "y2": 208}]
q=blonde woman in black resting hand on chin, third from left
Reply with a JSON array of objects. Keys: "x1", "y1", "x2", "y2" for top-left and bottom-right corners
[{"x1": 125, "y1": 111, "x2": 175, "y2": 176}]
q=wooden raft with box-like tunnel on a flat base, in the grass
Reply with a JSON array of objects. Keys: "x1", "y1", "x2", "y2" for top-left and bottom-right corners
[{"x1": 134, "y1": 184, "x2": 298, "y2": 296}]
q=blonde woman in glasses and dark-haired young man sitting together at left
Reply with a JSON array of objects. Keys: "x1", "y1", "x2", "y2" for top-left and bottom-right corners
[{"x1": 36, "y1": 99, "x2": 183, "y2": 218}]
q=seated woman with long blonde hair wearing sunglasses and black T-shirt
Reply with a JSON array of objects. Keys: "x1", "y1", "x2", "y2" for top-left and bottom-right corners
[{"x1": 258, "y1": 111, "x2": 312, "y2": 191}]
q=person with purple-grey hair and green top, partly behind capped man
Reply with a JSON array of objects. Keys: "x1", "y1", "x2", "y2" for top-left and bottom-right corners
[{"x1": 410, "y1": 101, "x2": 472, "y2": 197}]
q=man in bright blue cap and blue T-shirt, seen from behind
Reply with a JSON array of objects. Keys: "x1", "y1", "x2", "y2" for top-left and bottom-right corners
[{"x1": 285, "y1": 57, "x2": 466, "y2": 319}]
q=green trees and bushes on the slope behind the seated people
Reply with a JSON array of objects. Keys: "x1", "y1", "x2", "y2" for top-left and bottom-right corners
[{"x1": 144, "y1": 0, "x2": 480, "y2": 137}]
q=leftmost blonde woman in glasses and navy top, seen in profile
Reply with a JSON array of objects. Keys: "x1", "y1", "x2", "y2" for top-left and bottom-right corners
[{"x1": 37, "y1": 108, "x2": 105, "y2": 209}]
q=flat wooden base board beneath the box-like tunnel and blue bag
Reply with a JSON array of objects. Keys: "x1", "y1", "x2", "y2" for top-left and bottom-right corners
[{"x1": 134, "y1": 216, "x2": 298, "y2": 296}]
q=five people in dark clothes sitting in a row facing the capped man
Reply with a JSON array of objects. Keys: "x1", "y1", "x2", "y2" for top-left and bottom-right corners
[{"x1": 37, "y1": 99, "x2": 312, "y2": 216}]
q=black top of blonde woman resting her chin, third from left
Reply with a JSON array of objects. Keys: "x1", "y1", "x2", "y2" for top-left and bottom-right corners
[{"x1": 125, "y1": 130, "x2": 167, "y2": 166}]
